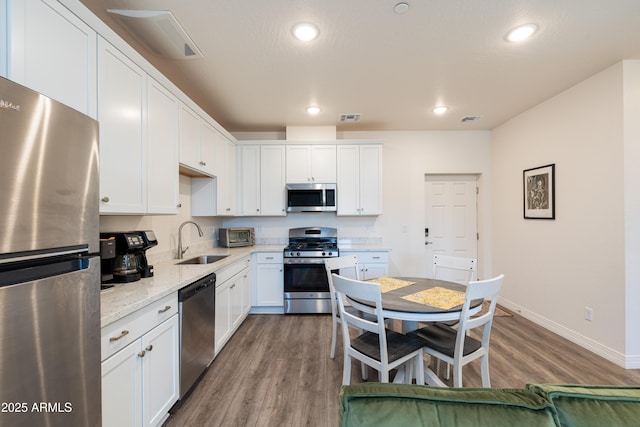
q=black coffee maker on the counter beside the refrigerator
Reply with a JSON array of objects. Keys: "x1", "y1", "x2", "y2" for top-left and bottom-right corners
[{"x1": 100, "y1": 231, "x2": 158, "y2": 283}]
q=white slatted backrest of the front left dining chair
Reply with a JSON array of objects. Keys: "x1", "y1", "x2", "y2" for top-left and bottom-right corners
[{"x1": 332, "y1": 273, "x2": 387, "y2": 348}]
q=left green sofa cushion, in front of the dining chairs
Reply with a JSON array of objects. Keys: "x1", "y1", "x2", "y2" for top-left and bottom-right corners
[{"x1": 340, "y1": 383, "x2": 558, "y2": 427}]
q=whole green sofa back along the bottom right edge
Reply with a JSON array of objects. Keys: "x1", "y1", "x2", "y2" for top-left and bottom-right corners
[{"x1": 340, "y1": 383, "x2": 640, "y2": 427}]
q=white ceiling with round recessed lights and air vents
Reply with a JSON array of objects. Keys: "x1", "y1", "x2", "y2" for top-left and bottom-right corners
[{"x1": 81, "y1": 0, "x2": 640, "y2": 132}]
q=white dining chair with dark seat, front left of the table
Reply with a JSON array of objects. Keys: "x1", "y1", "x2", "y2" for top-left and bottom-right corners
[{"x1": 333, "y1": 273, "x2": 425, "y2": 385}]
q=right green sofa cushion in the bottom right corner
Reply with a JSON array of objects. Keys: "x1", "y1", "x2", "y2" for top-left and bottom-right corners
[{"x1": 527, "y1": 384, "x2": 640, "y2": 427}]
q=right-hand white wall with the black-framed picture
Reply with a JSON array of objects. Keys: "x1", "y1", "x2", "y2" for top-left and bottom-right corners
[{"x1": 491, "y1": 63, "x2": 638, "y2": 365}]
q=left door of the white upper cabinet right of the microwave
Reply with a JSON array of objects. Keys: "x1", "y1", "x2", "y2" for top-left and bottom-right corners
[{"x1": 337, "y1": 145, "x2": 360, "y2": 215}]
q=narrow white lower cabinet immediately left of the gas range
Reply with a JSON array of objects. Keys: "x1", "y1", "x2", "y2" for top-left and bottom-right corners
[{"x1": 252, "y1": 252, "x2": 284, "y2": 313}]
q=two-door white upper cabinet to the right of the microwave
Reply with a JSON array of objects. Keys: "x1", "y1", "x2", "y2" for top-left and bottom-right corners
[{"x1": 337, "y1": 144, "x2": 382, "y2": 216}]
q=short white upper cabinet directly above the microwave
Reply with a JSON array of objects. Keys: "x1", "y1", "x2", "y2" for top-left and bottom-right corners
[{"x1": 286, "y1": 144, "x2": 336, "y2": 184}]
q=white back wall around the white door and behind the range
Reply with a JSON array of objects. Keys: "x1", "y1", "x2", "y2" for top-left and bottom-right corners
[{"x1": 230, "y1": 131, "x2": 491, "y2": 275}]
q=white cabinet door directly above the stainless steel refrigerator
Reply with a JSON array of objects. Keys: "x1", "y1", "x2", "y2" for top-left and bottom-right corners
[{"x1": 6, "y1": 0, "x2": 96, "y2": 118}]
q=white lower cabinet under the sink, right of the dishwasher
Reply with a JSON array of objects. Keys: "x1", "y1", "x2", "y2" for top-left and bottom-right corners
[{"x1": 215, "y1": 257, "x2": 251, "y2": 354}]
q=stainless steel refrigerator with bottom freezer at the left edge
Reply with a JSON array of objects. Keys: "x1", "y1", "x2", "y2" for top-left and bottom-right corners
[{"x1": 0, "y1": 78, "x2": 102, "y2": 427}]
